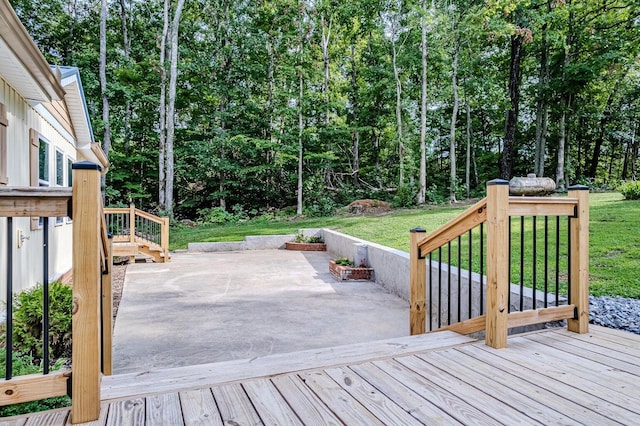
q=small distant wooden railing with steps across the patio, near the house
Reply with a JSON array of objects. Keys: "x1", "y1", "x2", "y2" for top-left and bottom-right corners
[{"x1": 104, "y1": 204, "x2": 170, "y2": 262}]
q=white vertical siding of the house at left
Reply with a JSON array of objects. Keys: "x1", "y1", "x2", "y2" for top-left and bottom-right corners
[{"x1": 0, "y1": 76, "x2": 77, "y2": 302}]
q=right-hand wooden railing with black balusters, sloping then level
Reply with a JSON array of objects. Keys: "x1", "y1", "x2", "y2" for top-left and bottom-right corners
[{"x1": 409, "y1": 180, "x2": 589, "y2": 348}]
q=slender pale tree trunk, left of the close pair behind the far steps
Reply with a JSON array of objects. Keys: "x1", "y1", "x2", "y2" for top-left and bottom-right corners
[{"x1": 158, "y1": 0, "x2": 170, "y2": 211}]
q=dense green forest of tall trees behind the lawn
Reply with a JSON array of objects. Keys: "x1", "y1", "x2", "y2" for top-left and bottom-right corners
[{"x1": 10, "y1": 0, "x2": 640, "y2": 219}]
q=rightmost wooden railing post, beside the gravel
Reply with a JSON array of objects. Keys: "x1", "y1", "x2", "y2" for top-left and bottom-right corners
[{"x1": 567, "y1": 185, "x2": 589, "y2": 333}]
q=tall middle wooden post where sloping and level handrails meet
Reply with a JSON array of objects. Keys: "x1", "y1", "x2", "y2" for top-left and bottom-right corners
[{"x1": 480, "y1": 179, "x2": 509, "y2": 349}]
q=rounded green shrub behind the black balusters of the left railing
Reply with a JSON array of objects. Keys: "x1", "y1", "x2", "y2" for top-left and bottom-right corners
[{"x1": 0, "y1": 281, "x2": 73, "y2": 364}]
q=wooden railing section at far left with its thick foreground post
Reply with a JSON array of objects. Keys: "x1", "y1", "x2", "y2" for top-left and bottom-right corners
[{"x1": 0, "y1": 162, "x2": 112, "y2": 423}]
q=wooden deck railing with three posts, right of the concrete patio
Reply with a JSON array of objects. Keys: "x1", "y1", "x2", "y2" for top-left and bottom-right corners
[{"x1": 409, "y1": 180, "x2": 589, "y2": 348}]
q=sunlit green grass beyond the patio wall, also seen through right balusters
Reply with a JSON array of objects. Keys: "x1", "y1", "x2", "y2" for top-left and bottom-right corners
[{"x1": 171, "y1": 193, "x2": 640, "y2": 298}]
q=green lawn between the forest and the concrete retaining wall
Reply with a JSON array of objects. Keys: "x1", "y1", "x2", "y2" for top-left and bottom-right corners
[{"x1": 171, "y1": 193, "x2": 640, "y2": 298}]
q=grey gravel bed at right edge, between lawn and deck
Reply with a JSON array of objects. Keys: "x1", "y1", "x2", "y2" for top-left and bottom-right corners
[{"x1": 589, "y1": 296, "x2": 640, "y2": 334}]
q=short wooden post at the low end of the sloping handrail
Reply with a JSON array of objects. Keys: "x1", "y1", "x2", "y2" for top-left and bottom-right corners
[{"x1": 409, "y1": 228, "x2": 427, "y2": 336}]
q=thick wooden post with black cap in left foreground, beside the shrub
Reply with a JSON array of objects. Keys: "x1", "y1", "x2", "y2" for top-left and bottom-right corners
[{"x1": 71, "y1": 162, "x2": 102, "y2": 423}]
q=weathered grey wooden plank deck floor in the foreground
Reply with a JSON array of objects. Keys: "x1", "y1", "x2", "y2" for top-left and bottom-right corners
[{"x1": 5, "y1": 326, "x2": 640, "y2": 425}]
